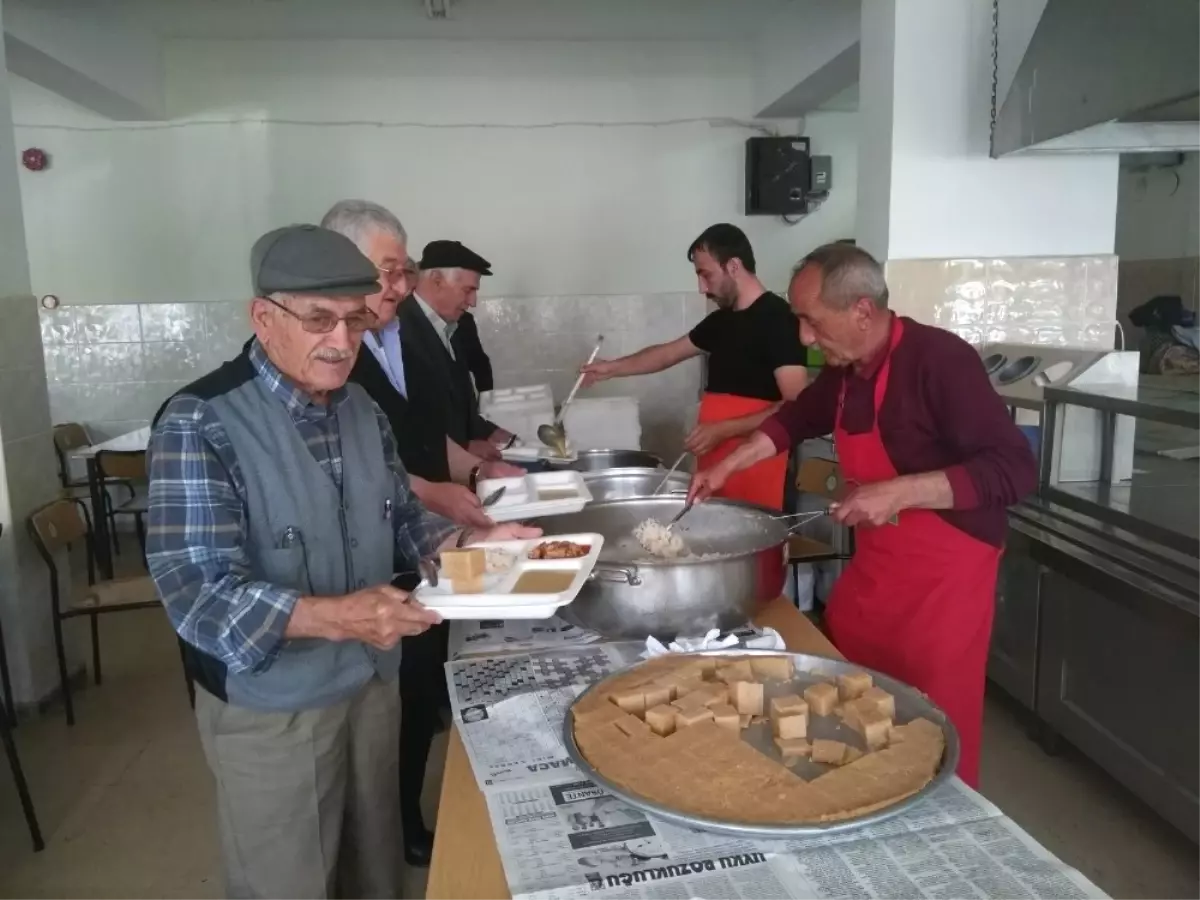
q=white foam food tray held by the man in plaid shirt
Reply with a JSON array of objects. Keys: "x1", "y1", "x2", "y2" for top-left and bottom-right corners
[{"x1": 413, "y1": 534, "x2": 604, "y2": 619}]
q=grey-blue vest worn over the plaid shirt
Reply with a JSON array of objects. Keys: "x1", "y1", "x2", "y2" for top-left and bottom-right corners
[{"x1": 211, "y1": 378, "x2": 400, "y2": 712}]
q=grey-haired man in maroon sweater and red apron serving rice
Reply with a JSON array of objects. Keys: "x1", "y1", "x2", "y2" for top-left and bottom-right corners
[{"x1": 692, "y1": 245, "x2": 1037, "y2": 786}]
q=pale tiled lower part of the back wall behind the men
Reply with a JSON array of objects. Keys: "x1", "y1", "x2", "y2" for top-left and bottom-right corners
[{"x1": 41, "y1": 294, "x2": 707, "y2": 454}]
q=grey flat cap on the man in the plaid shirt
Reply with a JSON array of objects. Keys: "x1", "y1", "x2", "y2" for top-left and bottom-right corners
[{"x1": 250, "y1": 224, "x2": 379, "y2": 296}]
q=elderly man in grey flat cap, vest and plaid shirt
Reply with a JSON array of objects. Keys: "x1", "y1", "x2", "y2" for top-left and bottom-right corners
[{"x1": 146, "y1": 226, "x2": 538, "y2": 900}]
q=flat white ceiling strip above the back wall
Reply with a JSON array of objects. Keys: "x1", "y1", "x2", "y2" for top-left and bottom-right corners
[{"x1": 110, "y1": 0, "x2": 811, "y2": 41}]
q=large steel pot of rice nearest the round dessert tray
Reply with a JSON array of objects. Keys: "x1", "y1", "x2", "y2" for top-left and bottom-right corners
[{"x1": 541, "y1": 497, "x2": 787, "y2": 640}]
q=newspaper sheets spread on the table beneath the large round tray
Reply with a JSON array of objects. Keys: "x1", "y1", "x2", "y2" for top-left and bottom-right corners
[{"x1": 446, "y1": 643, "x2": 1105, "y2": 900}]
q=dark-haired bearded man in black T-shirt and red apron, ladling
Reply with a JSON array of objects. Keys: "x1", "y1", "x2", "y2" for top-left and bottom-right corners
[{"x1": 582, "y1": 224, "x2": 808, "y2": 509}]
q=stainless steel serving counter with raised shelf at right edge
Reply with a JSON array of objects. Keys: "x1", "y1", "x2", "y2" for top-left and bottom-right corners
[{"x1": 988, "y1": 386, "x2": 1200, "y2": 842}]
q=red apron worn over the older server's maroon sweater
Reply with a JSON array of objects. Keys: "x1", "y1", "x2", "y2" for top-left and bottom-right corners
[{"x1": 826, "y1": 319, "x2": 1000, "y2": 787}]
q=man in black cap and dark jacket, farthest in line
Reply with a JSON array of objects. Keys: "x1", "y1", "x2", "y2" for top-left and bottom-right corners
[{"x1": 398, "y1": 240, "x2": 514, "y2": 472}]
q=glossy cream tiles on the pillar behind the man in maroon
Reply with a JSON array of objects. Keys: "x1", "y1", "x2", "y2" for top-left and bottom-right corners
[{"x1": 887, "y1": 256, "x2": 1117, "y2": 349}]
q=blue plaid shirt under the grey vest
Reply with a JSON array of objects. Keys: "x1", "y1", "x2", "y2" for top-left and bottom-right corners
[{"x1": 146, "y1": 341, "x2": 456, "y2": 672}]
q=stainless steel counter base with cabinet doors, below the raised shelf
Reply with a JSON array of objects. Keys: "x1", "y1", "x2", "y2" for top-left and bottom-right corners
[{"x1": 989, "y1": 504, "x2": 1200, "y2": 842}]
